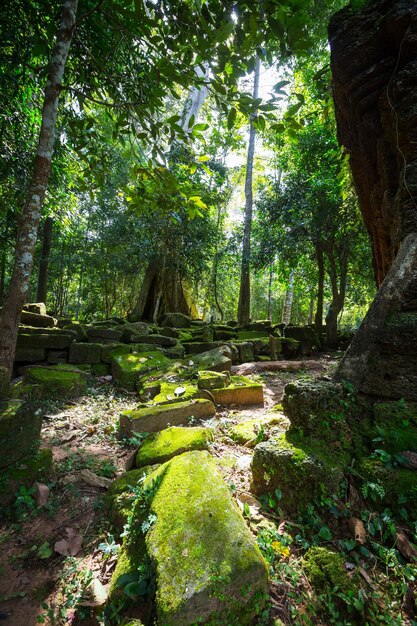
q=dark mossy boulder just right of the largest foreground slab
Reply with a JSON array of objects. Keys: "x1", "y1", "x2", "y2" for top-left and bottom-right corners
[{"x1": 252, "y1": 434, "x2": 343, "y2": 515}]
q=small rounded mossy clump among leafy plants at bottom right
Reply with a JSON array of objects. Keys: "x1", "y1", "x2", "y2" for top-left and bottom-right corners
[{"x1": 303, "y1": 546, "x2": 359, "y2": 594}]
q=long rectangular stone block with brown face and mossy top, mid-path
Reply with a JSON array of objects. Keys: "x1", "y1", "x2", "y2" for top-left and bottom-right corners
[{"x1": 120, "y1": 399, "x2": 216, "y2": 435}]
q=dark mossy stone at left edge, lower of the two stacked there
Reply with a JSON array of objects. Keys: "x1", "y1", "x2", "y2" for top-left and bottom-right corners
[{"x1": 0, "y1": 448, "x2": 53, "y2": 507}]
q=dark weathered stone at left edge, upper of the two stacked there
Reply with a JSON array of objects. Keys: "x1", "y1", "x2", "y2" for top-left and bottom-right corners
[{"x1": 0, "y1": 400, "x2": 42, "y2": 467}]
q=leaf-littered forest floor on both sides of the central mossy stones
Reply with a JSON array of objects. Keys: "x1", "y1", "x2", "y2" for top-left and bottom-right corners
[{"x1": 0, "y1": 355, "x2": 411, "y2": 626}]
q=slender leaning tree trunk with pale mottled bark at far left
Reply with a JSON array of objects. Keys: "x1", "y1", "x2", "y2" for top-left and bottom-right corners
[{"x1": 0, "y1": 0, "x2": 78, "y2": 376}]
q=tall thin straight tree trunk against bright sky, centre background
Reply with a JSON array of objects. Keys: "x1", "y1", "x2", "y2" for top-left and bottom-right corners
[{"x1": 237, "y1": 56, "x2": 261, "y2": 325}]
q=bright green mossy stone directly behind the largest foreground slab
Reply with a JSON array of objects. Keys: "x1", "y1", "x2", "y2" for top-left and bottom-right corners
[{"x1": 136, "y1": 426, "x2": 213, "y2": 467}]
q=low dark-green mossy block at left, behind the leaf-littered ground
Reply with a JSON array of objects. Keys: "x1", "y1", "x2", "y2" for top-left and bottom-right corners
[{"x1": 23, "y1": 365, "x2": 86, "y2": 398}]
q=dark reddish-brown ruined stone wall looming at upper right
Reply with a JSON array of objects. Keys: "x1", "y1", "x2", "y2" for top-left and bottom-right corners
[{"x1": 329, "y1": 0, "x2": 417, "y2": 285}]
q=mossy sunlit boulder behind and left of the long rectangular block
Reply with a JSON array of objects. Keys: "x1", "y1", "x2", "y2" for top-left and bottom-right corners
[{"x1": 112, "y1": 351, "x2": 171, "y2": 391}]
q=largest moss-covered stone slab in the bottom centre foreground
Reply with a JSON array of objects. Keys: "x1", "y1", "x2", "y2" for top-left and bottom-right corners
[{"x1": 145, "y1": 452, "x2": 268, "y2": 626}]
